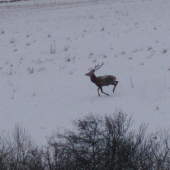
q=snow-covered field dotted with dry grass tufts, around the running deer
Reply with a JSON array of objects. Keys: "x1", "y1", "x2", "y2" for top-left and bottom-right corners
[{"x1": 0, "y1": 0, "x2": 170, "y2": 144}]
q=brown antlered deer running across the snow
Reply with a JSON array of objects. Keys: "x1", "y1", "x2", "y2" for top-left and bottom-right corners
[{"x1": 85, "y1": 63, "x2": 118, "y2": 97}]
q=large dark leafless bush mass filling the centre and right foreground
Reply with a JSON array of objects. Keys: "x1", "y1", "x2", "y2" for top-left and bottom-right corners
[{"x1": 48, "y1": 111, "x2": 170, "y2": 170}]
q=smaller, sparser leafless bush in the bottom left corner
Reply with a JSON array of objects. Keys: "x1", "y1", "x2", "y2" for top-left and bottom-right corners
[{"x1": 0, "y1": 125, "x2": 43, "y2": 170}]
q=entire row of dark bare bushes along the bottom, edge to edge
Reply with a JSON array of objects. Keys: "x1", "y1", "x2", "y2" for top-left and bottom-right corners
[{"x1": 0, "y1": 111, "x2": 170, "y2": 170}]
